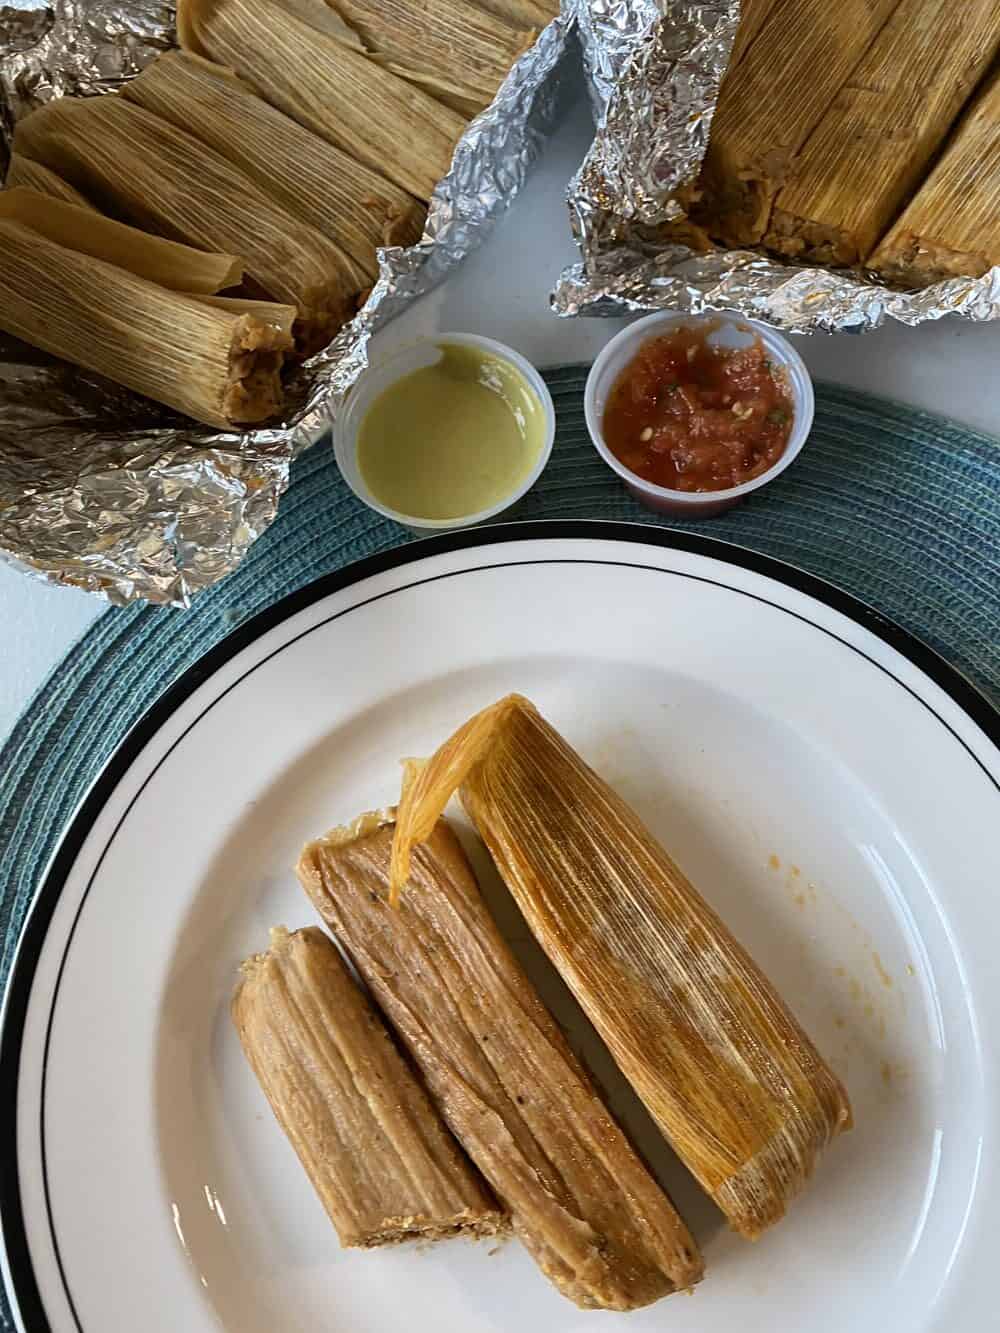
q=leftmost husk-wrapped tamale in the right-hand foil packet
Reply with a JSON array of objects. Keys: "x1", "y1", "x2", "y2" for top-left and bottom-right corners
[{"x1": 692, "y1": 0, "x2": 899, "y2": 245}]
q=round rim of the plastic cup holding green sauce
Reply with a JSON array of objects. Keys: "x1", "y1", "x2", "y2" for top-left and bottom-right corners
[{"x1": 333, "y1": 331, "x2": 556, "y2": 532}]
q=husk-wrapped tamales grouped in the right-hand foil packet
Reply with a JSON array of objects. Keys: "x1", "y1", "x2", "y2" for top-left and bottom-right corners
[{"x1": 669, "y1": 0, "x2": 1000, "y2": 287}]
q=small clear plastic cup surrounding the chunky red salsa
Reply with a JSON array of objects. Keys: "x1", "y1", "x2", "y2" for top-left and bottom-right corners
[{"x1": 584, "y1": 311, "x2": 815, "y2": 519}]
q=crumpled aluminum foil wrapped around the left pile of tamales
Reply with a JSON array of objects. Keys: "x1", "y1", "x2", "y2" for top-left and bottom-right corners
[{"x1": 0, "y1": 0, "x2": 572, "y2": 605}]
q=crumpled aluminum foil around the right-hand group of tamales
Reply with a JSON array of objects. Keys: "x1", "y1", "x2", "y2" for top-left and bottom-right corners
[{"x1": 552, "y1": 0, "x2": 1000, "y2": 333}]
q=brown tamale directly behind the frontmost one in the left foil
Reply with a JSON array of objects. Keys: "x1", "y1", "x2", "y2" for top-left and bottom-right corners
[{"x1": 15, "y1": 96, "x2": 367, "y2": 352}]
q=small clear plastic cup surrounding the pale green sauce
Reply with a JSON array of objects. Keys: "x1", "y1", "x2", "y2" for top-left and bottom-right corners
[{"x1": 333, "y1": 333, "x2": 556, "y2": 536}]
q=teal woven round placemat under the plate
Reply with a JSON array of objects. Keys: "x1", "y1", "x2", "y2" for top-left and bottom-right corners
[{"x1": 0, "y1": 367, "x2": 1000, "y2": 1329}]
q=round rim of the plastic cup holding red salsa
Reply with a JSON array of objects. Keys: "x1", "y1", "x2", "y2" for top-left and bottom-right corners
[{"x1": 584, "y1": 311, "x2": 816, "y2": 508}]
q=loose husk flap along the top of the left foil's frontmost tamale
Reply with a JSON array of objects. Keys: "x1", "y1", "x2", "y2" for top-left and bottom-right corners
[{"x1": 0, "y1": 187, "x2": 243, "y2": 295}]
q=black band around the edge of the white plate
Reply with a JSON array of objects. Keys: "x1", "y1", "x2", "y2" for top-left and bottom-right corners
[{"x1": 0, "y1": 520, "x2": 1000, "y2": 1333}]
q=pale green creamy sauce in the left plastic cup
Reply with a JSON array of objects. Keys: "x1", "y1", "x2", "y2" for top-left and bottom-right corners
[{"x1": 357, "y1": 343, "x2": 545, "y2": 520}]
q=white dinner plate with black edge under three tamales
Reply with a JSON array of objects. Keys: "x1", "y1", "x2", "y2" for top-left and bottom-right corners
[{"x1": 0, "y1": 524, "x2": 1000, "y2": 1333}]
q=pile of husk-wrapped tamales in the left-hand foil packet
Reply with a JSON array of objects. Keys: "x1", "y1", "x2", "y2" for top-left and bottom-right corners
[{"x1": 0, "y1": 0, "x2": 551, "y2": 429}]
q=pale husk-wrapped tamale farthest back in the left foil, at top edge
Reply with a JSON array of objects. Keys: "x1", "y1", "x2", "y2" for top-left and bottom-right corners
[{"x1": 327, "y1": 0, "x2": 535, "y2": 115}]
